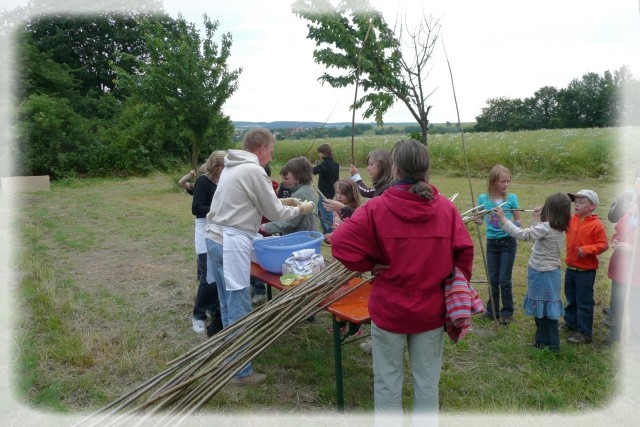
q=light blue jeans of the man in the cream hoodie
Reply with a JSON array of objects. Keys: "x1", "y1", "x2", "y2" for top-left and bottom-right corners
[{"x1": 207, "y1": 239, "x2": 252, "y2": 378}]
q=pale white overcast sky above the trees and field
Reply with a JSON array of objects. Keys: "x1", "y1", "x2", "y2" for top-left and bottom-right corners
[{"x1": 2, "y1": 0, "x2": 640, "y2": 123}]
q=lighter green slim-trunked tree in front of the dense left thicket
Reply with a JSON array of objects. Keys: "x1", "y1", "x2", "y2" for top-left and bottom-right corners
[{"x1": 114, "y1": 15, "x2": 242, "y2": 169}]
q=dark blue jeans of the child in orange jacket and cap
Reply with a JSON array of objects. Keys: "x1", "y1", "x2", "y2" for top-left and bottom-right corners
[{"x1": 564, "y1": 268, "x2": 596, "y2": 337}]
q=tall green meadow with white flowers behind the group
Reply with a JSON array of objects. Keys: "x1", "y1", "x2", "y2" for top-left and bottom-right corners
[{"x1": 274, "y1": 128, "x2": 621, "y2": 180}]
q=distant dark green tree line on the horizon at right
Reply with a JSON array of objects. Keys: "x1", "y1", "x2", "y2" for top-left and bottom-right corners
[{"x1": 474, "y1": 66, "x2": 640, "y2": 132}]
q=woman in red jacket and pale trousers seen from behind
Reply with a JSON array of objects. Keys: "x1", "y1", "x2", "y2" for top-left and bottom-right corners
[{"x1": 331, "y1": 140, "x2": 473, "y2": 422}]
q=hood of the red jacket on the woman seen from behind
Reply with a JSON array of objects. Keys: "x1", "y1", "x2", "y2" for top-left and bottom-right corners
[{"x1": 380, "y1": 184, "x2": 441, "y2": 223}]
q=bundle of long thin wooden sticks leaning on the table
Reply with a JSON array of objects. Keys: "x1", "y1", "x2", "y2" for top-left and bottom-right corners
[{"x1": 80, "y1": 262, "x2": 369, "y2": 426}]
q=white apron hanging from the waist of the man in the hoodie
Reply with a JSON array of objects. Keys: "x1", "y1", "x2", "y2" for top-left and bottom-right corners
[{"x1": 222, "y1": 227, "x2": 255, "y2": 291}]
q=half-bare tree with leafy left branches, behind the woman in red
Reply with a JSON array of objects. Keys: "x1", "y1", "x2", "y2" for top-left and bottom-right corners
[{"x1": 292, "y1": 0, "x2": 440, "y2": 144}]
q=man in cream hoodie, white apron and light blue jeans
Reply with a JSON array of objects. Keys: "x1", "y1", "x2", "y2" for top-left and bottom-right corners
[{"x1": 205, "y1": 128, "x2": 315, "y2": 385}]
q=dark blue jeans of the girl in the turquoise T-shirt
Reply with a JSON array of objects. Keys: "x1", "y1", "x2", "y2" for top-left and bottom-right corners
[{"x1": 487, "y1": 236, "x2": 518, "y2": 318}]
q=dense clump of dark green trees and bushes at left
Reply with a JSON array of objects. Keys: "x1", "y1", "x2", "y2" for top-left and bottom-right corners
[{"x1": 0, "y1": 0, "x2": 242, "y2": 179}]
